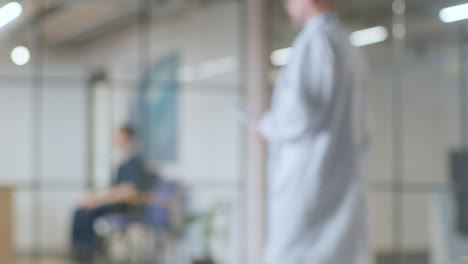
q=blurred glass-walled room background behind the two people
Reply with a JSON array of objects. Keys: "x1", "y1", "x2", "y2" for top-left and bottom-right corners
[{"x1": 0, "y1": 0, "x2": 468, "y2": 264}]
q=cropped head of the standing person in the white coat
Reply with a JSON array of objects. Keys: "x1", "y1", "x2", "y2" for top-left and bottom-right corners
[{"x1": 283, "y1": 0, "x2": 334, "y2": 27}]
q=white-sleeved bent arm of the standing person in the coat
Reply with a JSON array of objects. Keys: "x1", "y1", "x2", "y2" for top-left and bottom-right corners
[{"x1": 258, "y1": 37, "x2": 335, "y2": 142}]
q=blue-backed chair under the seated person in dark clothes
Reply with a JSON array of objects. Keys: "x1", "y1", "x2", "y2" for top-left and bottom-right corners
[{"x1": 94, "y1": 180, "x2": 184, "y2": 264}]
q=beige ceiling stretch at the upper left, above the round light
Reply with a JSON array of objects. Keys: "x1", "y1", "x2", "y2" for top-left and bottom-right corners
[{"x1": 0, "y1": 0, "x2": 230, "y2": 48}]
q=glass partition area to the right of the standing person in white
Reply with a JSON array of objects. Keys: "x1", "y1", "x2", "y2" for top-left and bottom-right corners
[{"x1": 271, "y1": 0, "x2": 467, "y2": 264}]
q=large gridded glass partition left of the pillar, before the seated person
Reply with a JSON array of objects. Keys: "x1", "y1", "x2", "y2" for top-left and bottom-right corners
[{"x1": 0, "y1": 0, "x2": 244, "y2": 264}]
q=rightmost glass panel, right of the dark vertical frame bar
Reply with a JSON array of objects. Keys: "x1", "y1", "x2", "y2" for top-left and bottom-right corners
[{"x1": 394, "y1": 1, "x2": 464, "y2": 263}]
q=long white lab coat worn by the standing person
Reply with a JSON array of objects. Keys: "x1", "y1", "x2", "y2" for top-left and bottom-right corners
[{"x1": 260, "y1": 14, "x2": 373, "y2": 264}]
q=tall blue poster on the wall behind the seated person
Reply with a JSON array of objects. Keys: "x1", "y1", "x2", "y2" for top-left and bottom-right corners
[{"x1": 137, "y1": 55, "x2": 179, "y2": 162}]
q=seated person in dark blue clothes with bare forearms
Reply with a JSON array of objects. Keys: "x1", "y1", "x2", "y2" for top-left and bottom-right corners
[{"x1": 72, "y1": 126, "x2": 152, "y2": 262}]
